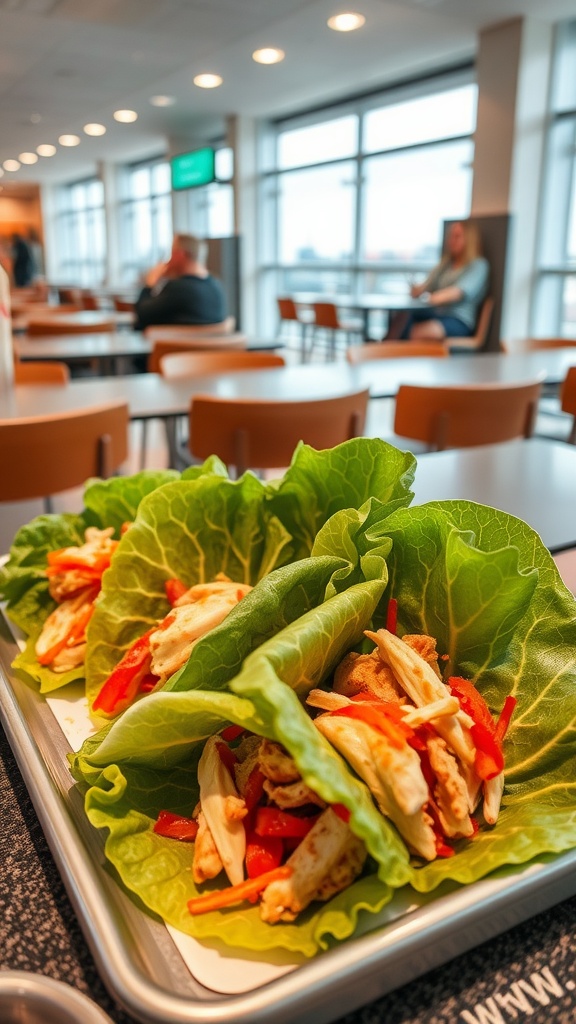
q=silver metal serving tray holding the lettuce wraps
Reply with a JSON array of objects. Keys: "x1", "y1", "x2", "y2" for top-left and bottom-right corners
[{"x1": 0, "y1": 616, "x2": 576, "y2": 1024}]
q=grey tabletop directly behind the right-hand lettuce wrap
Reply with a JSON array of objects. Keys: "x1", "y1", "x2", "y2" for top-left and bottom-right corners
[{"x1": 412, "y1": 437, "x2": 576, "y2": 553}]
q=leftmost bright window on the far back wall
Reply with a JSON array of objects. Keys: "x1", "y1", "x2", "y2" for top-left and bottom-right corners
[{"x1": 55, "y1": 178, "x2": 106, "y2": 288}]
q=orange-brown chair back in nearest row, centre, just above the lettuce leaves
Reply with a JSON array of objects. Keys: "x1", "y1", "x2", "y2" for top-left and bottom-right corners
[{"x1": 190, "y1": 390, "x2": 369, "y2": 476}]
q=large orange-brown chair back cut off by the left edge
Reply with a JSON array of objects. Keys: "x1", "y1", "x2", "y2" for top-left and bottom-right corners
[{"x1": 0, "y1": 402, "x2": 128, "y2": 509}]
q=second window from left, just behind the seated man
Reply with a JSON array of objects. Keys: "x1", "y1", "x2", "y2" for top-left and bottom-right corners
[{"x1": 120, "y1": 160, "x2": 172, "y2": 285}]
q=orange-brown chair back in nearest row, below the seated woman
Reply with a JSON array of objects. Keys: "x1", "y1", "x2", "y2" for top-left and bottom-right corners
[{"x1": 394, "y1": 380, "x2": 541, "y2": 452}]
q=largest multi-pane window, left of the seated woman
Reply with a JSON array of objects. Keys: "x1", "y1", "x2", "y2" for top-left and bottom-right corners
[{"x1": 261, "y1": 70, "x2": 477, "y2": 329}]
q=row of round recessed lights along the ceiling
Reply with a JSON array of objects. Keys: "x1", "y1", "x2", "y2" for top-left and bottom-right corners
[{"x1": 0, "y1": 11, "x2": 366, "y2": 177}]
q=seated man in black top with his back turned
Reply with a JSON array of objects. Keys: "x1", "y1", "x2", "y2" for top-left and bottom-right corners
[{"x1": 134, "y1": 234, "x2": 227, "y2": 331}]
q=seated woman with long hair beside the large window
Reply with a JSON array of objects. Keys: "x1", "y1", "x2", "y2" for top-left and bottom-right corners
[{"x1": 388, "y1": 220, "x2": 490, "y2": 339}]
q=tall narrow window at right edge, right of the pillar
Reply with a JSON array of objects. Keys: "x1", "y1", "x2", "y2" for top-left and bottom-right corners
[{"x1": 533, "y1": 22, "x2": 576, "y2": 338}]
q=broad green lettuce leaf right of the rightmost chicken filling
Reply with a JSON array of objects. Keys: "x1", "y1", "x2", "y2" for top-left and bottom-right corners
[{"x1": 377, "y1": 502, "x2": 576, "y2": 892}]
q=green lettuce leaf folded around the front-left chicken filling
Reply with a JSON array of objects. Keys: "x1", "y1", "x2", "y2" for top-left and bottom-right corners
[{"x1": 73, "y1": 579, "x2": 410, "y2": 955}]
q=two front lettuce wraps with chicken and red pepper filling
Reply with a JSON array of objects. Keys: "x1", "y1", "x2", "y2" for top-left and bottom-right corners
[{"x1": 73, "y1": 489, "x2": 576, "y2": 955}]
